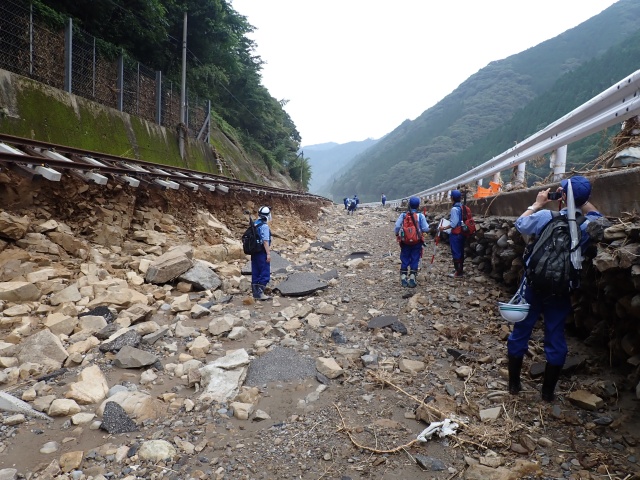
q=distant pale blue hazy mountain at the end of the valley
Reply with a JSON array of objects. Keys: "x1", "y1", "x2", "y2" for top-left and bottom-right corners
[{"x1": 302, "y1": 138, "x2": 377, "y2": 195}]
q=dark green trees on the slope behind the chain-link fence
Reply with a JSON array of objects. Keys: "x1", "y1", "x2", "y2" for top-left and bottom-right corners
[{"x1": 36, "y1": 0, "x2": 311, "y2": 185}]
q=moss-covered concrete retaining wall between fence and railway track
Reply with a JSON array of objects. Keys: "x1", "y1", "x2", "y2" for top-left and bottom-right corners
[{"x1": 0, "y1": 70, "x2": 289, "y2": 188}]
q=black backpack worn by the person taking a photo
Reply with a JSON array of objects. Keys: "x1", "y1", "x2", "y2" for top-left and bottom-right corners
[{"x1": 524, "y1": 212, "x2": 586, "y2": 296}]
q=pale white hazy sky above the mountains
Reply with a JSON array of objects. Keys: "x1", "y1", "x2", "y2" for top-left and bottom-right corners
[{"x1": 231, "y1": 0, "x2": 615, "y2": 146}]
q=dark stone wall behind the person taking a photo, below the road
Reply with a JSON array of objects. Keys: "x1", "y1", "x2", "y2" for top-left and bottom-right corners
[{"x1": 452, "y1": 214, "x2": 640, "y2": 377}]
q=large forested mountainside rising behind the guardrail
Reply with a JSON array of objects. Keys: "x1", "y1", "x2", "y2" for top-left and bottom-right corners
[{"x1": 331, "y1": 0, "x2": 640, "y2": 201}]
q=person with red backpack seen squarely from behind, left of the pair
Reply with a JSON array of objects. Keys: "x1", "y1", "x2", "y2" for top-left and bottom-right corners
[{"x1": 395, "y1": 197, "x2": 429, "y2": 288}]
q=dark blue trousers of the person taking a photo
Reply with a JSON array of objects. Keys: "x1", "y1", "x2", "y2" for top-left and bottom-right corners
[{"x1": 507, "y1": 289, "x2": 571, "y2": 365}]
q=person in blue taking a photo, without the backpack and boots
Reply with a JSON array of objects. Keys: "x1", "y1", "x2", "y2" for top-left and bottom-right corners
[{"x1": 507, "y1": 176, "x2": 602, "y2": 402}]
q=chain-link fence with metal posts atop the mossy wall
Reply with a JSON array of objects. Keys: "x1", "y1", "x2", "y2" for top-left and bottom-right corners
[{"x1": 0, "y1": 0, "x2": 208, "y2": 141}]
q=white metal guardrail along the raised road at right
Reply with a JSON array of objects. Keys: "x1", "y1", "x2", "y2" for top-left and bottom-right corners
[{"x1": 366, "y1": 70, "x2": 640, "y2": 205}]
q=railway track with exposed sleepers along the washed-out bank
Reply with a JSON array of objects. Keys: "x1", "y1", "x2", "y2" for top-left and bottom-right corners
[{"x1": 0, "y1": 134, "x2": 327, "y2": 201}]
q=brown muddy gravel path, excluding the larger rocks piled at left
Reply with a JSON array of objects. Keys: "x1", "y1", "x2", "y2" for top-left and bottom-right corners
[{"x1": 0, "y1": 203, "x2": 640, "y2": 480}]
